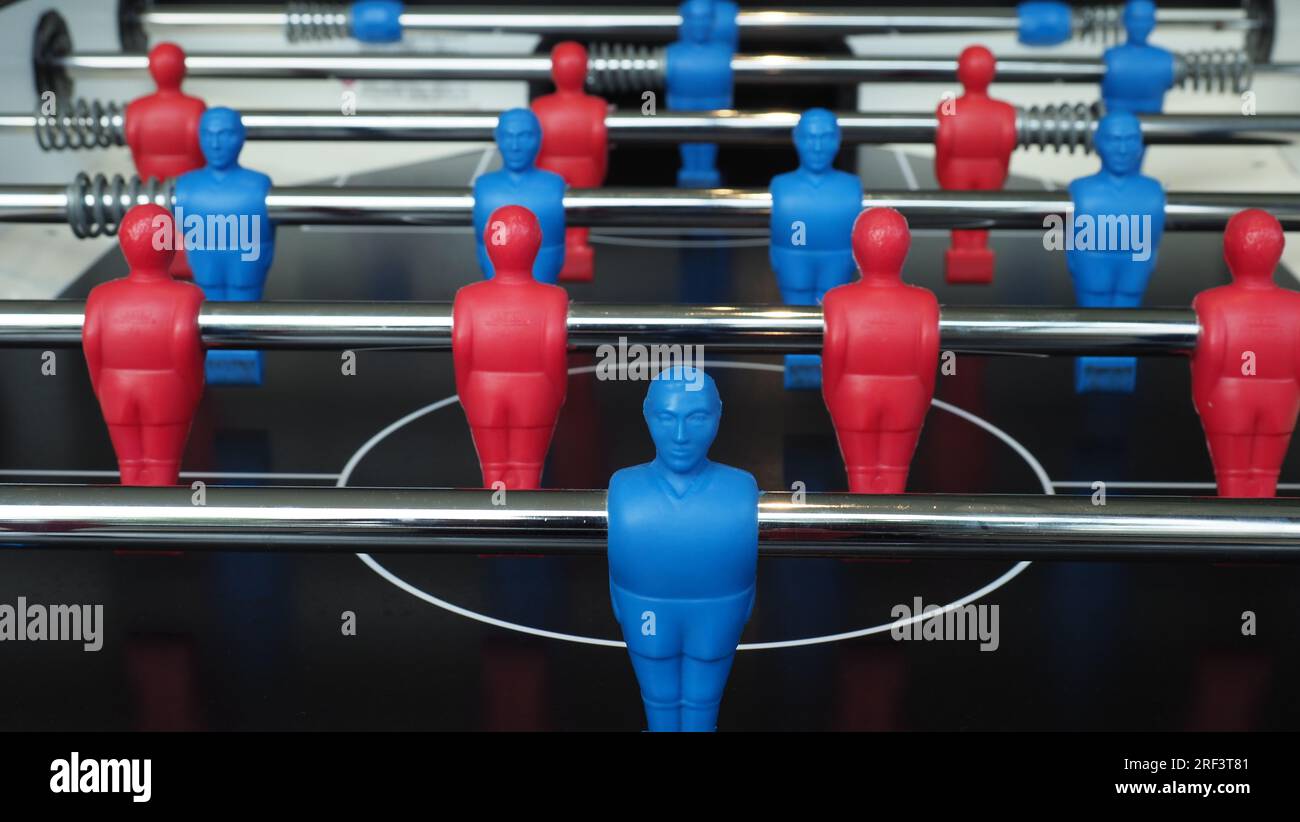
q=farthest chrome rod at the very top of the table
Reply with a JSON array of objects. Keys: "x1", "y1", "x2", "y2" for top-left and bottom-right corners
[{"x1": 140, "y1": 4, "x2": 1260, "y2": 40}]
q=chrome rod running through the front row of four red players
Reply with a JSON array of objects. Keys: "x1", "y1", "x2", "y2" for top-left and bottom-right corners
[{"x1": 0, "y1": 300, "x2": 1200, "y2": 355}]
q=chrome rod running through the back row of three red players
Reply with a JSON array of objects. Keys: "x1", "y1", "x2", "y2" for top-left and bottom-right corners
[{"x1": 12, "y1": 105, "x2": 1300, "y2": 151}]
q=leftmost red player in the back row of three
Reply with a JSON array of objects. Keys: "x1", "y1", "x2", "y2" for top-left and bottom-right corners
[{"x1": 126, "y1": 43, "x2": 207, "y2": 280}]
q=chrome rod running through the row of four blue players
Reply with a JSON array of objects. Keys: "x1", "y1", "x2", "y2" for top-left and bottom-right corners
[{"x1": 10, "y1": 181, "x2": 1300, "y2": 232}]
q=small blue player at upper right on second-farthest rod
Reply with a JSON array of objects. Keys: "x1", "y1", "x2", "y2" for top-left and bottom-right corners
[{"x1": 1101, "y1": 0, "x2": 1174, "y2": 114}]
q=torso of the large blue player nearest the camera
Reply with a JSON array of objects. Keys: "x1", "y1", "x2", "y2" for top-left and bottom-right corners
[{"x1": 607, "y1": 462, "x2": 758, "y2": 659}]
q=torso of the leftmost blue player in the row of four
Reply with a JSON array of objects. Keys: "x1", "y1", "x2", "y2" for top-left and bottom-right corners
[{"x1": 176, "y1": 166, "x2": 276, "y2": 300}]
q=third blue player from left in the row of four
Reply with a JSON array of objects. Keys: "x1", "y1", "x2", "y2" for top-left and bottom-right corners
[{"x1": 770, "y1": 108, "x2": 862, "y2": 389}]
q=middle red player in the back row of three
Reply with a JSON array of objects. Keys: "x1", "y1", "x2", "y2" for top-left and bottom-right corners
[{"x1": 532, "y1": 42, "x2": 610, "y2": 282}]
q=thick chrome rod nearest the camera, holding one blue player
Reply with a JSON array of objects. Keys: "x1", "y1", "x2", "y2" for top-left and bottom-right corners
[{"x1": 0, "y1": 485, "x2": 1300, "y2": 562}]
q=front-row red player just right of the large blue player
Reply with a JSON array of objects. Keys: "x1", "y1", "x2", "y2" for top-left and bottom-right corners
[{"x1": 822, "y1": 208, "x2": 939, "y2": 494}]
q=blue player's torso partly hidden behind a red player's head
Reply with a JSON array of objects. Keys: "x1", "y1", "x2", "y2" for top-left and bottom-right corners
[{"x1": 473, "y1": 168, "x2": 564, "y2": 284}]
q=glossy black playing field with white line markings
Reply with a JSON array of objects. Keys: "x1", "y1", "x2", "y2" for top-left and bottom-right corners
[{"x1": 0, "y1": 150, "x2": 1300, "y2": 731}]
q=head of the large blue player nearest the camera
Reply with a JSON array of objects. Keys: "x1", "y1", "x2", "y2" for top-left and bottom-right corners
[{"x1": 641, "y1": 365, "x2": 723, "y2": 473}]
